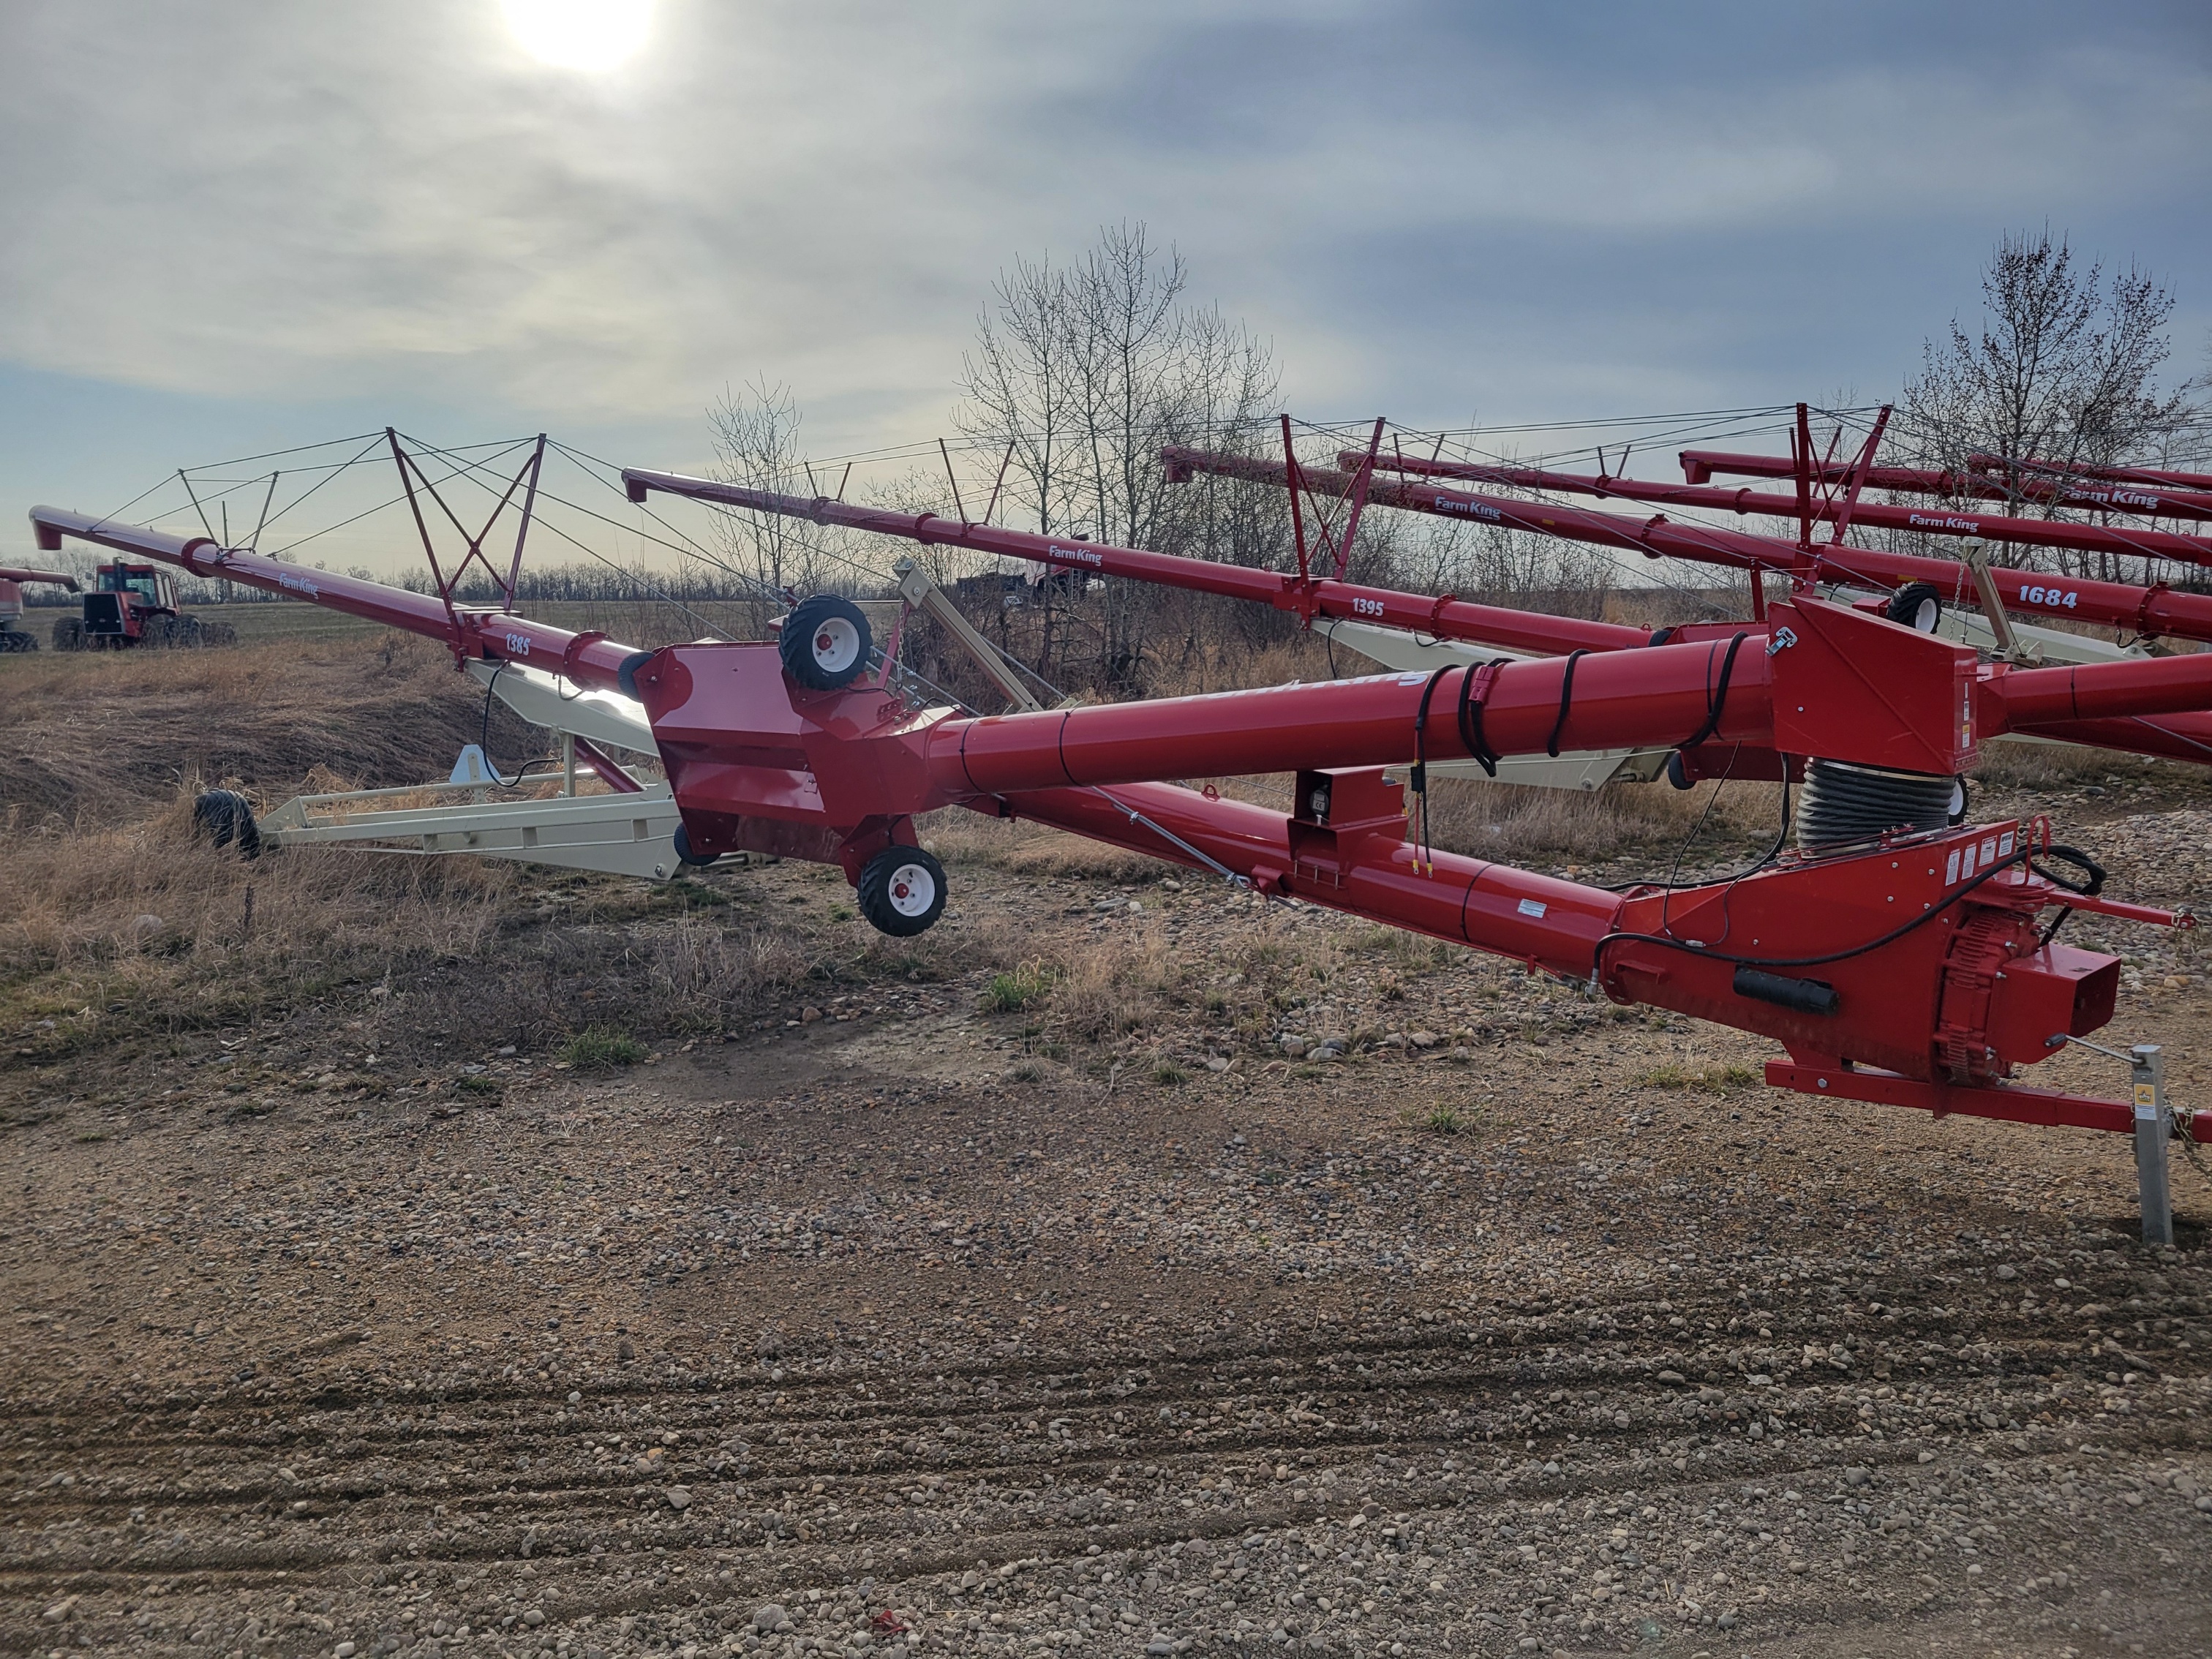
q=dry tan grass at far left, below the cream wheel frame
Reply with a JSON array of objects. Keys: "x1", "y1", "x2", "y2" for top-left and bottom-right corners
[{"x1": 0, "y1": 813, "x2": 845, "y2": 1064}]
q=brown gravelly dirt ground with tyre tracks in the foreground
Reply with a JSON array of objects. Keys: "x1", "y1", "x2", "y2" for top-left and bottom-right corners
[{"x1": 0, "y1": 641, "x2": 2212, "y2": 1659}]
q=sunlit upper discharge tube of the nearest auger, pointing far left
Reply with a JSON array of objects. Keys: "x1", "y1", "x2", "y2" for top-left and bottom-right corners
[{"x1": 31, "y1": 506, "x2": 646, "y2": 690}]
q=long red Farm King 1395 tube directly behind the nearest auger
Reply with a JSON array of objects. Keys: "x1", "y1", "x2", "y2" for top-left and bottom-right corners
[{"x1": 622, "y1": 467, "x2": 1650, "y2": 652}]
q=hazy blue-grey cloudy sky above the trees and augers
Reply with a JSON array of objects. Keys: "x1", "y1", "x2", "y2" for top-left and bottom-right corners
[{"x1": 0, "y1": 0, "x2": 2212, "y2": 557}]
